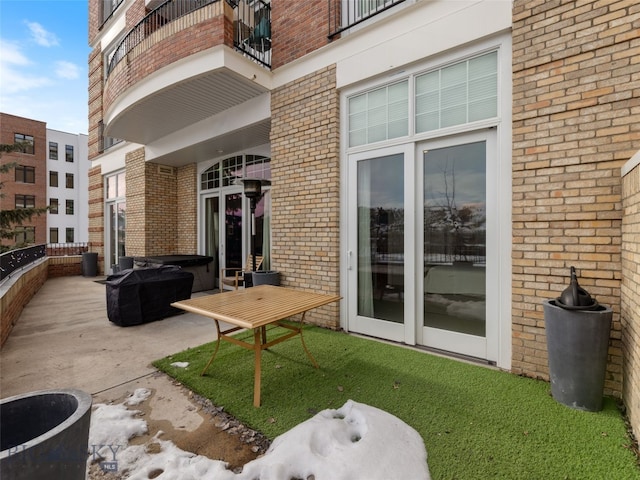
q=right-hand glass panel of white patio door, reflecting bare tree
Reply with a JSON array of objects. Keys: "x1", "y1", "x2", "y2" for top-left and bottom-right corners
[{"x1": 422, "y1": 141, "x2": 487, "y2": 358}]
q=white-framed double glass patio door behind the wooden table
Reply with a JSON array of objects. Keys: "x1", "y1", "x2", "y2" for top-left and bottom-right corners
[{"x1": 346, "y1": 130, "x2": 499, "y2": 360}]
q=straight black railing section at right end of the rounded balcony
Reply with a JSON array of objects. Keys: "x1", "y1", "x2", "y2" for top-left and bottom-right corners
[{"x1": 234, "y1": 0, "x2": 271, "y2": 68}]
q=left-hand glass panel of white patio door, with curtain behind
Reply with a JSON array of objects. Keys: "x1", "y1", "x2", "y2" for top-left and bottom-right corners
[{"x1": 350, "y1": 153, "x2": 405, "y2": 341}]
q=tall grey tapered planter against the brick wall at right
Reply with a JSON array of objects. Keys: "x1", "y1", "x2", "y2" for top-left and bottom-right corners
[{"x1": 543, "y1": 300, "x2": 613, "y2": 412}]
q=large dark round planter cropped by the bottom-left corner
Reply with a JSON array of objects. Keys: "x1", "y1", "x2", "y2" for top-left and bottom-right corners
[{"x1": 0, "y1": 389, "x2": 92, "y2": 480}]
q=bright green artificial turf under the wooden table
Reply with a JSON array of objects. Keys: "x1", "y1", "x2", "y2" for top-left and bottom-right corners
[{"x1": 154, "y1": 326, "x2": 640, "y2": 480}]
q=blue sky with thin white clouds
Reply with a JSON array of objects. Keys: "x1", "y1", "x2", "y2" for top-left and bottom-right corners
[{"x1": 0, "y1": 0, "x2": 90, "y2": 134}]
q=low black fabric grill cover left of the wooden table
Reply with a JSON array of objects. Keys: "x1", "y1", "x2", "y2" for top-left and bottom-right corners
[{"x1": 106, "y1": 266, "x2": 193, "y2": 327}]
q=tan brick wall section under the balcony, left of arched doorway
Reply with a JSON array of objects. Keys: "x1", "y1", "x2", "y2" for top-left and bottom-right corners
[{"x1": 125, "y1": 148, "x2": 178, "y2": 257}]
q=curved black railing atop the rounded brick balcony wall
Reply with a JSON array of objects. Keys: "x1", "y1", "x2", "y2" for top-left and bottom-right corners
[{"x1": 106, "y1": 0, "x2": 224, "y2": 77}]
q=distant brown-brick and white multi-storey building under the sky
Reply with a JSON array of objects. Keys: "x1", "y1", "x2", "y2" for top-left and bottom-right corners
[{"x1": 0, "y1": 113, "x2": 90, "y2": 245}]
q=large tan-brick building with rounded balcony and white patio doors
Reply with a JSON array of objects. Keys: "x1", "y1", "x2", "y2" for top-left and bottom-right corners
[{"x1": 89, "y1": 0, "x2": 640, "y2": 436}]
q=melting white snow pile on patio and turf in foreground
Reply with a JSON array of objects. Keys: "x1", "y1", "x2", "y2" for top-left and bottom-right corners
[{"x1": 87, "y1": 388, "x2": 431, "y2": 480}]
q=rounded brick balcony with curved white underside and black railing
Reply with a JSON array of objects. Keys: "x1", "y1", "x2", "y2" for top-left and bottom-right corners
[{"x1": 101, "y1": 0, "x2": 271, "y2": 166}]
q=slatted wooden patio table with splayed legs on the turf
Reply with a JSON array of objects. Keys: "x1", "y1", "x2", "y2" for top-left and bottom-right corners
[{"x1": 171, "y1": 285, "x2": 340, "y2": 407}]
